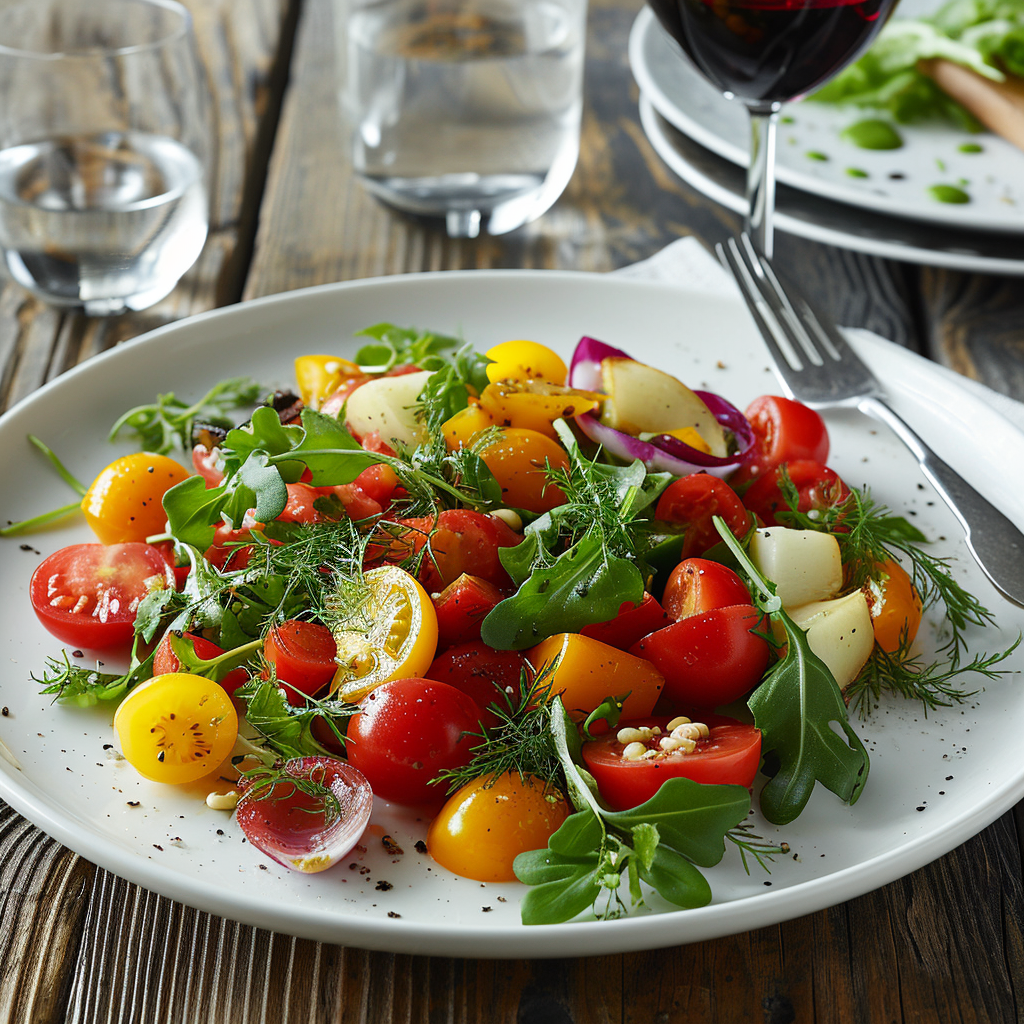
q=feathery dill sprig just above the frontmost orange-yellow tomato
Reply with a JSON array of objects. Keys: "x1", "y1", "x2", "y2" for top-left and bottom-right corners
[{"x1": 437, "y1": 663, "x2": 564, "y2": 794}]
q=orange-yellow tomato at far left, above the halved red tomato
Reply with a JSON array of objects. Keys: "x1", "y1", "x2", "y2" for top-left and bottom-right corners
[{"x1": 82, "y1": 452, "x2": 188, "y2": 544}]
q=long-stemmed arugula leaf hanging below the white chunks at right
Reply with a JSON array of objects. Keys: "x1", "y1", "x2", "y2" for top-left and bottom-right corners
[{"x1": 714, "y1": 516, "x2": 868, "y2": 824}]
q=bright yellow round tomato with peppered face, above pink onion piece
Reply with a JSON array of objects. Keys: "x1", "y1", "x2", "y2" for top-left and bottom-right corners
[{"x1": 114, "y1": 672, "x2": 239, "y2": 782}]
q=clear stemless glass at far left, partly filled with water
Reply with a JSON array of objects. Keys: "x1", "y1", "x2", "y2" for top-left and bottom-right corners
[{"x1": 0, "y1": 0, "x2": 211, "y2": 315}]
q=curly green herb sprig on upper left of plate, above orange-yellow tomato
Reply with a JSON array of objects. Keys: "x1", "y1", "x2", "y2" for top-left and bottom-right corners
[{"x1": 110, "y1": 377, "x2": 266, "y2": 455}]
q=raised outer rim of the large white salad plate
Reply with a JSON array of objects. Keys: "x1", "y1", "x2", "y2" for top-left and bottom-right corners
[{"x1": 0, "y1": 270, "x2": 1024, "y2": 958}]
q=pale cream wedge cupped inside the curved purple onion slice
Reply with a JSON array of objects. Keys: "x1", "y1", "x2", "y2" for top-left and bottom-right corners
[{"x1": 601, "y1": 356, "x2": 727, "y2": 458}]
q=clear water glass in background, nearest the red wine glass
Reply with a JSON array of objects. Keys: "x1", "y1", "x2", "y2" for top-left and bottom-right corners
[{"x1": 335, "y1": 0, "x2": 587, "y2": 238}]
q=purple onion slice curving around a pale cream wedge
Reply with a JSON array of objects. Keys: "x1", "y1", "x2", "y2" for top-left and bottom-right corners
[{"x1": 569, "y1": 337, "x2": 754, "y2": 476}]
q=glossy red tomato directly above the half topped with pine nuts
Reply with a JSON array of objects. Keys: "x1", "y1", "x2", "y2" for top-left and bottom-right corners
[{"x1": 630, "y1": 604, "x2": 769, "y2": 708}]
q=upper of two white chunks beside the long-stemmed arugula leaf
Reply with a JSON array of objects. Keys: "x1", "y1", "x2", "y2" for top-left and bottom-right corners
[{"x1": 750, "y1": 526, "x2": 843, "y2": 608}]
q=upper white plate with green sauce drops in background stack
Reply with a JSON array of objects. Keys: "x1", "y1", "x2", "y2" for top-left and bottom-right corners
[{"x1": 630, "y1": 5, "x2": 1024, "y2": 233}]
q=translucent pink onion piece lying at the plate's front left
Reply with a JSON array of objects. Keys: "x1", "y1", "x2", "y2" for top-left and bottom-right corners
[{"x1": 236, "y1": 757, "x2": 374, "y2": 873}]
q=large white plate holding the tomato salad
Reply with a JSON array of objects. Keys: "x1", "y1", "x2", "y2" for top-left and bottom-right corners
[{"x1": 0, "y1": 271, "x2": 1024, "y2": 957}]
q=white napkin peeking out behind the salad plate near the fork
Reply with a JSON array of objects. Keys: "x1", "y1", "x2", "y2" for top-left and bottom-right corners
[{"x1": 613, "y1": 238, "x2": 1024, "y2": 430}]
